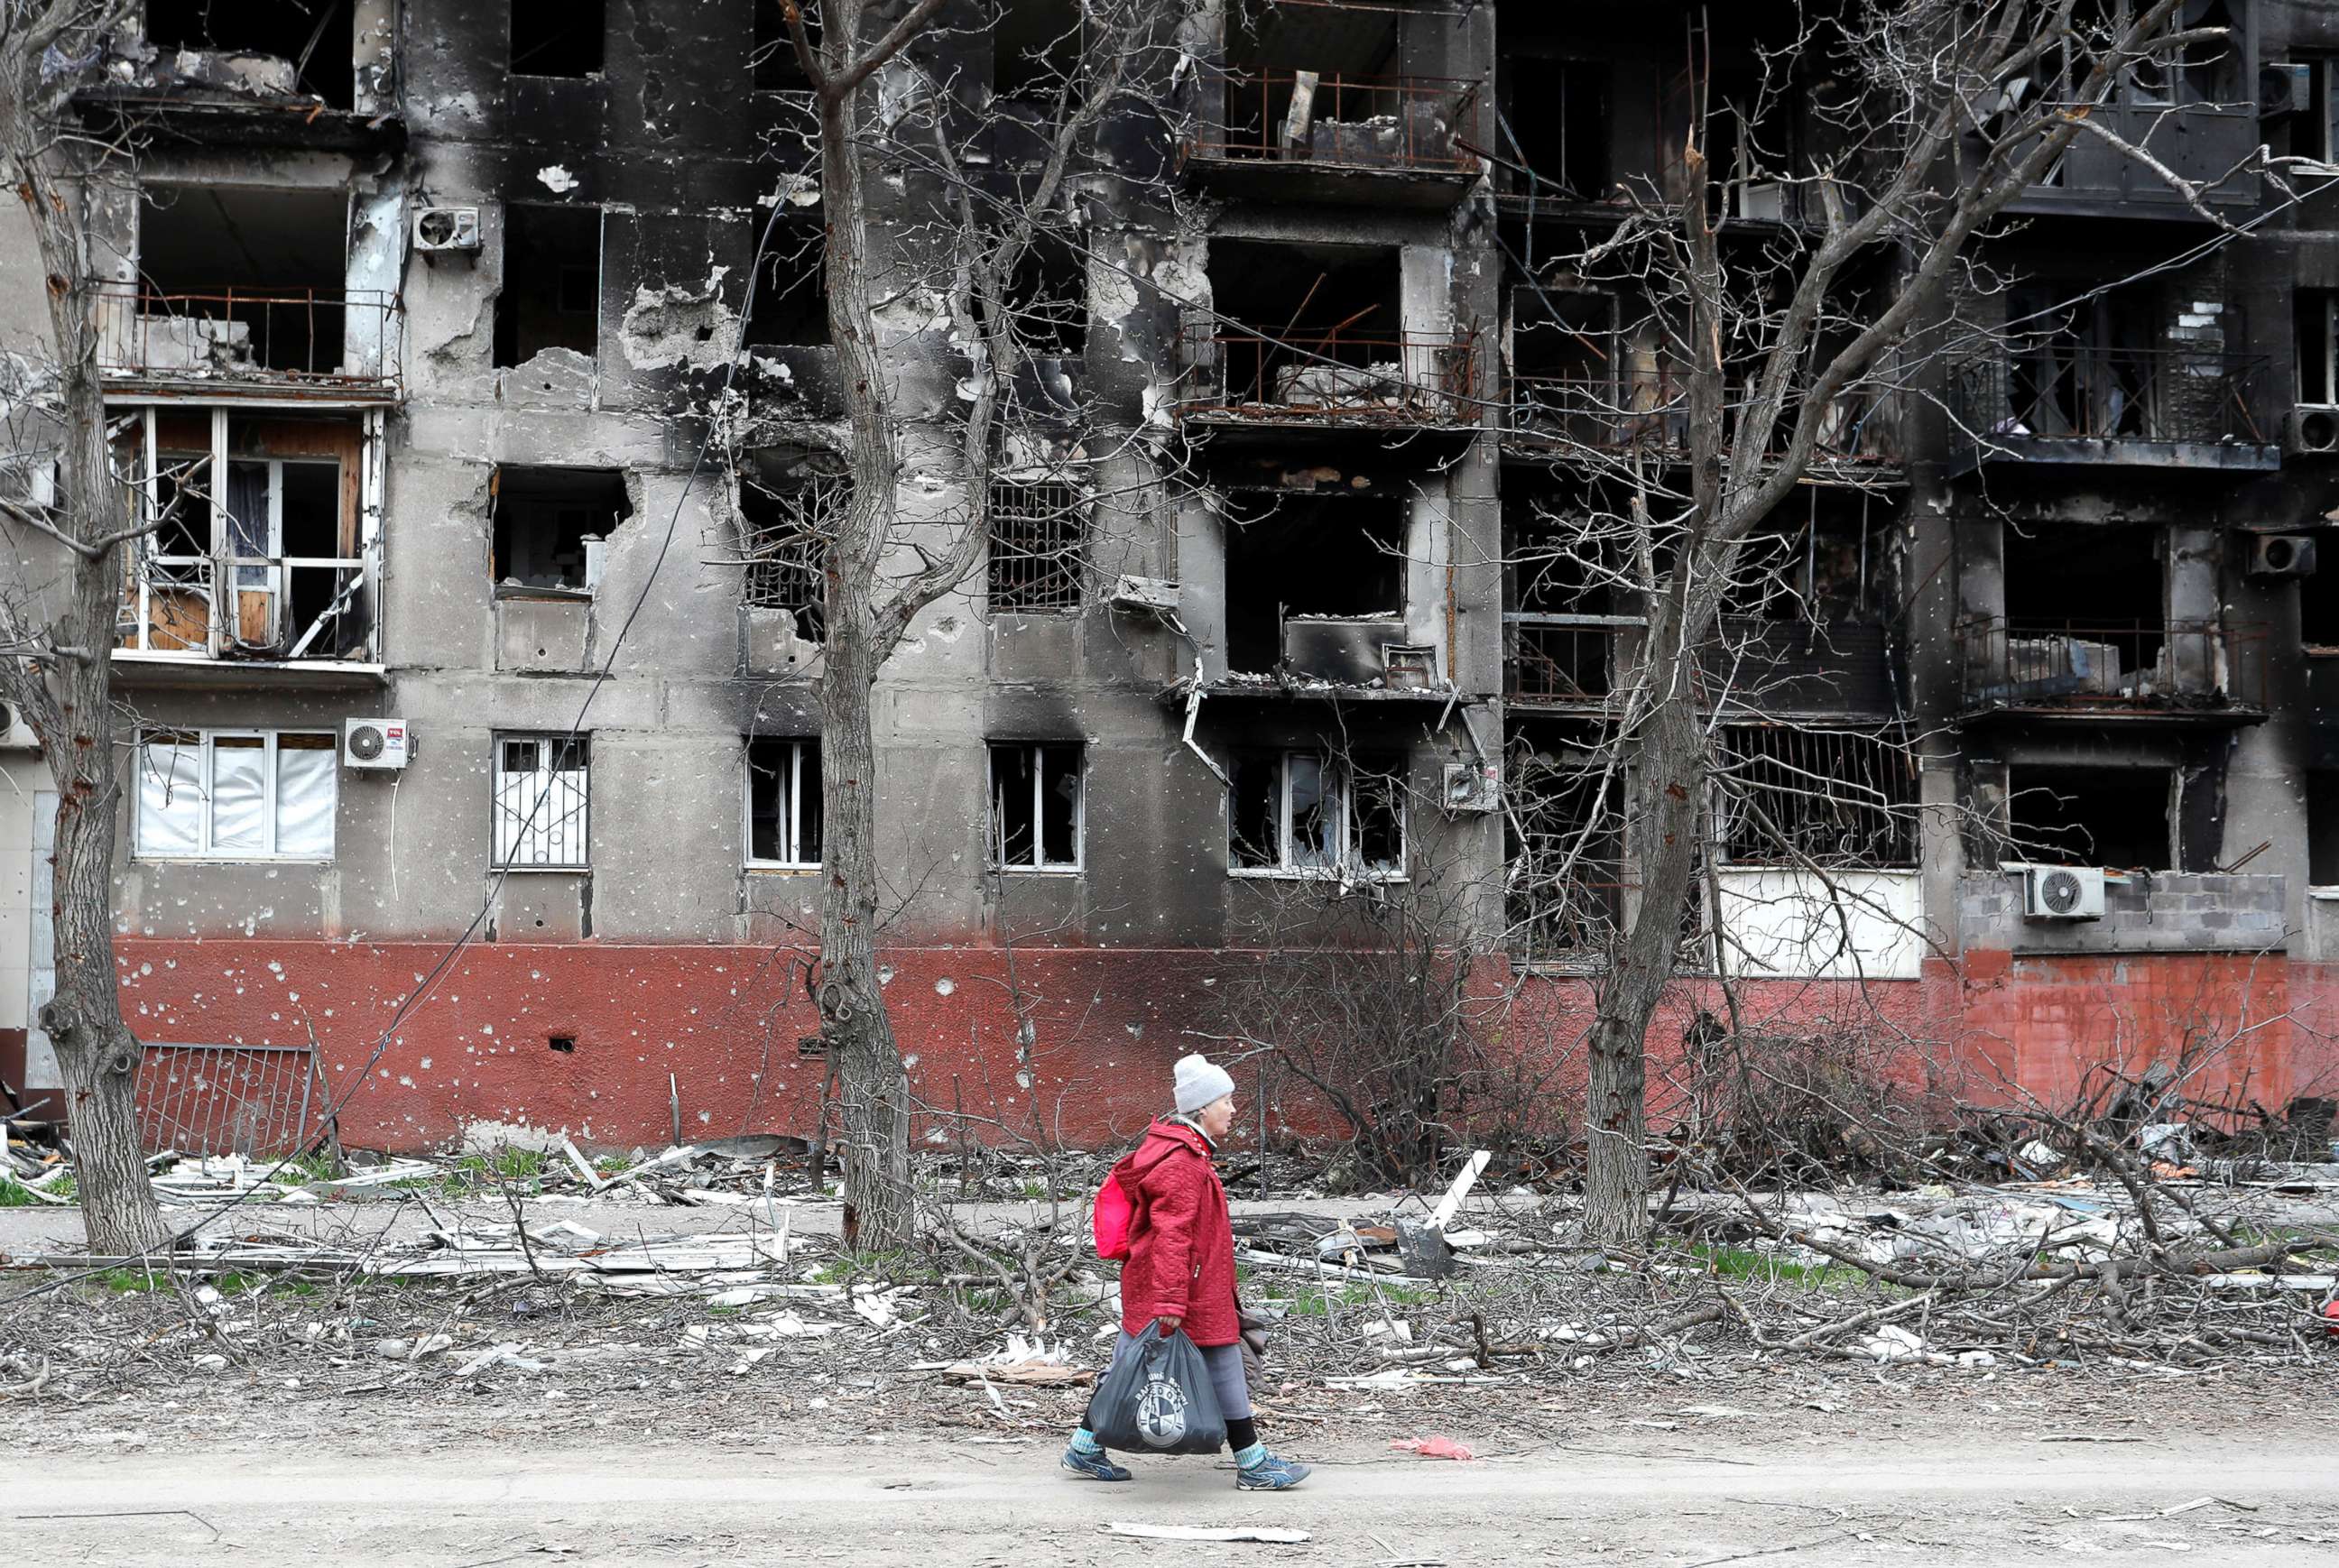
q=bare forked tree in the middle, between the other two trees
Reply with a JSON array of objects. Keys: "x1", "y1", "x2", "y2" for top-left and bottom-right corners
[{"x1": 783, "y1": 0, "x2": 1177, "y2": 1250}]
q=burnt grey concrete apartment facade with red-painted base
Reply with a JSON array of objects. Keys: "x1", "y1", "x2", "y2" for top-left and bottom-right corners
[{"x1": 0, "y1": 0, "x2": 2339, "y2": 1145}]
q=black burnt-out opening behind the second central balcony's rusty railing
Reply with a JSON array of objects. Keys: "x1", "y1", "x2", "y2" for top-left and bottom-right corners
[{"x1": 1206, "y1": 241, "x2": 1427, "y2": 409}]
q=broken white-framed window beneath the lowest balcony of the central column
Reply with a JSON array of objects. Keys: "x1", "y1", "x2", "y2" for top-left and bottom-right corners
[{"x1": 1225, "y1": 750, "x2": 1406, "y2": 879}]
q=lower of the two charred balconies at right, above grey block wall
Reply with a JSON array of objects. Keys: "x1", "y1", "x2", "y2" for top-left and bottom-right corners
[{"x1": 1958, "y1": 614, "x2": 2269, "y2": 727}]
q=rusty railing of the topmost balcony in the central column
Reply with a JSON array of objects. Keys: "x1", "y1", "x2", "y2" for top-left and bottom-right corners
[{"x1": 1186, "y1": 70, "x2": 1478, "y2": 175}]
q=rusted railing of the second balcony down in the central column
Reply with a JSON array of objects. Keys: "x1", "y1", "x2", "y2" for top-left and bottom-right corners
[{"x1": 1179, "y1": 325, "x2": 1478, "y2": 425}]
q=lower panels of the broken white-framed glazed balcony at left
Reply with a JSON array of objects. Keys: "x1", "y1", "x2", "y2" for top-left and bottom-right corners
[{"x1": 119, "y1": 554, "x2": 374, "y2": 664}]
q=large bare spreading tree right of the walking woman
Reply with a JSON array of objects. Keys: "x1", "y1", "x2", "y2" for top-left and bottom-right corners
[{"x1": 1496, "y1": 0, "x2": 2224, "y2": 1241}]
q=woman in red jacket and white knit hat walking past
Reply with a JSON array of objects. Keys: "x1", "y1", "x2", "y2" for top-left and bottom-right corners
[{"x1": 1064, "y1": 1056, "x2": 1308, "y2": 1491}]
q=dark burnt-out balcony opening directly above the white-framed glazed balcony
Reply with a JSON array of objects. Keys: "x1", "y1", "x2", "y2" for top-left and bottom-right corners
[{"x1": 135, "y1": 182, "x2": 348, "y2": 376}]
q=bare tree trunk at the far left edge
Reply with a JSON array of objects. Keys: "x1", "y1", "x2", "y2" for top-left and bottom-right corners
[{"x1": 0, "y1": 0, "x2": 163, "y2": 1255}]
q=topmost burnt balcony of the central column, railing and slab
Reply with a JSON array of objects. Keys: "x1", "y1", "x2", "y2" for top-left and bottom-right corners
[{"x1": 1184, "y1": 70, "x2": 1481, "y2": 208}]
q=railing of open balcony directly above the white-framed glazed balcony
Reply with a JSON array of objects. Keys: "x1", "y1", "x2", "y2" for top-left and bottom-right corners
[{"x1": 98, "y1": 282, "x2": 402, "y2": 392}]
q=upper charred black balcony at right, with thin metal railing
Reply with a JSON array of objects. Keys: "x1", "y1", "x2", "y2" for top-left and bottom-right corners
[{"x1": 1948, "y1": 353, "x2": 2283, "y2": 472}]
